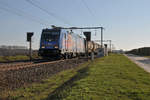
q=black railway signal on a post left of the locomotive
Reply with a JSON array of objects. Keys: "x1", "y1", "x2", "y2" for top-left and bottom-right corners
[{"x1": 27, "y1": 32, "x2": 34, "y2": 61}]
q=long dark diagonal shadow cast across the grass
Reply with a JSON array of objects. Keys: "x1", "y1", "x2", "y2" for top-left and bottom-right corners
[{"x1": 44, "y1": 67, "x2": 89, "y2": 100}]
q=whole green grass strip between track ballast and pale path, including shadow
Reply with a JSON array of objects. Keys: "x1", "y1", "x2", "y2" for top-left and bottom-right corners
[{"x1": 1, "y1": 54, "x2": 150, "y2": 100}]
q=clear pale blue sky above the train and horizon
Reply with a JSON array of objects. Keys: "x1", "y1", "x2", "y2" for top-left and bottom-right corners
[{"x1": 0, "y1": 0, "x2": 150, "y2": 50}]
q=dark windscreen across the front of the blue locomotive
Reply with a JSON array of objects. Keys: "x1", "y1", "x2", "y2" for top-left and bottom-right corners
[{"x1": 41, "y1": 31, "x2": 60, "y2": 42}]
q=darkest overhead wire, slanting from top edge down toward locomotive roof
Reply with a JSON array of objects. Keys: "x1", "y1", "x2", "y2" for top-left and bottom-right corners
[{"x1": 26, "y1": 0, "x2": 71, "y2": 25}]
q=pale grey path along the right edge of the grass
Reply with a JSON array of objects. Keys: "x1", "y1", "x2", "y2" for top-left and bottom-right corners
[{"x1": 125, "y1": 54, "x2": 150, "y2": 73}]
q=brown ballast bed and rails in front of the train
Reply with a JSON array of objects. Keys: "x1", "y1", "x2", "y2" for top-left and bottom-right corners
[{"x1": 0, "y1": 58, "x2": 86, "y2": 91}]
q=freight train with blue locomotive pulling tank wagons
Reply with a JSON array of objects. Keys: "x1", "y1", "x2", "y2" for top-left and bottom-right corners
[{"x1": 39, "y1": 28, "x2": 100, "y2": 58}]
